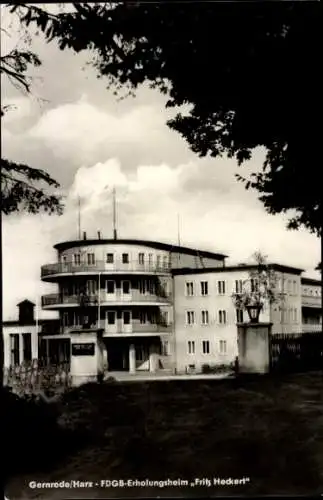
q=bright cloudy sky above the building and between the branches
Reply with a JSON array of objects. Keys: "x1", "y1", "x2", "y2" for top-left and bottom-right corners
[{"x1": 1, "y1": 6, "x2": 321, "y2": 319}]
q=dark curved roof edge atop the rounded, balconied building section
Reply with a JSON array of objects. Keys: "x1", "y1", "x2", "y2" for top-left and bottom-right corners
[{"x1": 54, "y1": 239, "x2": 227, "y2": 260}]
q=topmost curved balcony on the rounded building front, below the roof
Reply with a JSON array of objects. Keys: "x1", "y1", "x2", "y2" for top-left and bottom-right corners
[{"x1": 41, "y1": 261, "x2": 171, "y2": 281}]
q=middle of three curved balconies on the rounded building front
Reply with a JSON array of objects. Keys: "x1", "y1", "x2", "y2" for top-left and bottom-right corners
[{"x1": 42, "y1": 290, "x2": 171, "y2": 309}]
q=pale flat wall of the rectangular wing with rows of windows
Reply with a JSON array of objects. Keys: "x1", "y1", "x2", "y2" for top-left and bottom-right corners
[{"x1": 174, "y1": 269, "x2": 301, "y2": 372}]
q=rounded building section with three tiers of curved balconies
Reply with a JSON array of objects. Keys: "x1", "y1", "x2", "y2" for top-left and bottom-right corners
[{"x1": 41, "y1": 239, "x2": 226, "y2": 371}]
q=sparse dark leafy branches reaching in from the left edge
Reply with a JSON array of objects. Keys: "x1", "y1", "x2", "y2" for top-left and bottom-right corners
[{"x1": 0, "y1": 30, "x2": 63, "y2": 215}]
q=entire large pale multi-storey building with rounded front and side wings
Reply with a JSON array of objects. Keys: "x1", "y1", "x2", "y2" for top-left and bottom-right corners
[{"x1": 4, "y1": 234, "x2": 322, "y2": 373}]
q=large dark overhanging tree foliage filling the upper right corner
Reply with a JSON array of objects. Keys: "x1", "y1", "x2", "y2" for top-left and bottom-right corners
[{"x1": 6, "y1": 1, "x2": 321, "y2": 236}]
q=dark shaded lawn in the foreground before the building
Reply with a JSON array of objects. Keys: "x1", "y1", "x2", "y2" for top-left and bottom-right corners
[{"x1": 6, "y1": 373, "x2": 323, "y2": 500}]
